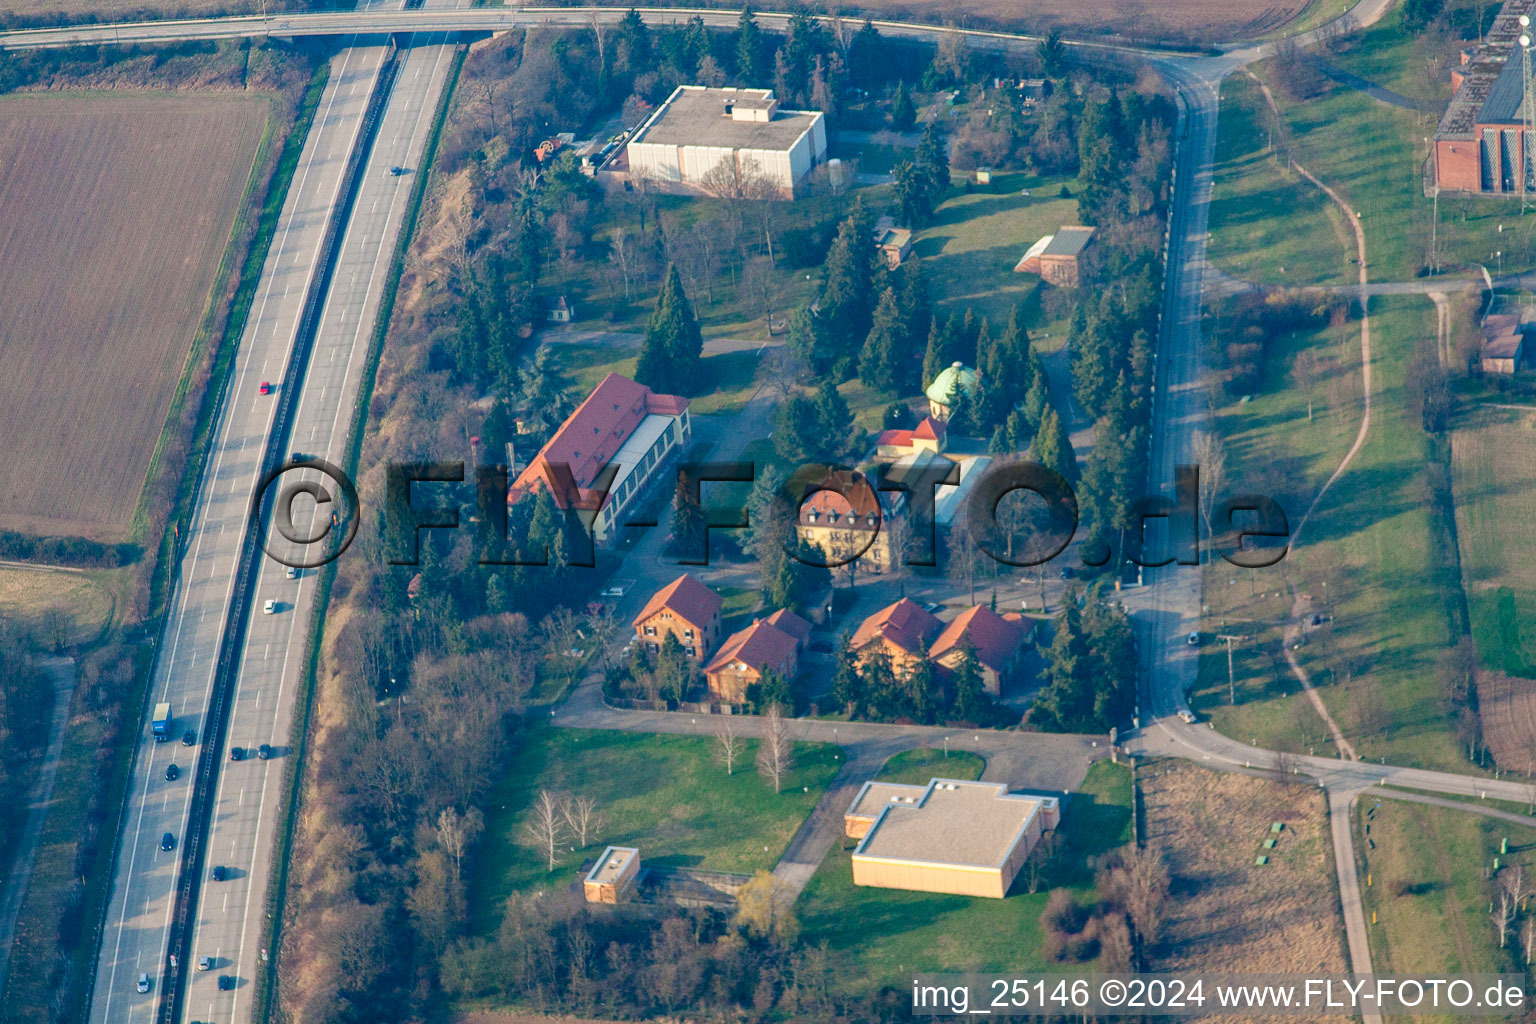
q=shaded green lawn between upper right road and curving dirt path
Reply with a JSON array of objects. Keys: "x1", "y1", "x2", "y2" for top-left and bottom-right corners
[{"x1": 1210, "y1": 75, "x2": 1355, "y2": 286}]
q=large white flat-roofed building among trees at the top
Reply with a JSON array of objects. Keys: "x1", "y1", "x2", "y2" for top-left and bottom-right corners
[{"x1": 625, "y1": 86, "x2": 826, "y2": 198}]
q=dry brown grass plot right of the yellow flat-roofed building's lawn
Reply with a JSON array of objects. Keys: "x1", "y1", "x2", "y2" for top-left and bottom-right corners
[{"x1": 1137, "y1": 760, "x2": 1349, "y2": 973}]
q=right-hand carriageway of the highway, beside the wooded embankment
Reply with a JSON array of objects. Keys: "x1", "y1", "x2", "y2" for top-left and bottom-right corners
[{"x1": 184, "y1": 20, "x2": 453, "y2": 1022}]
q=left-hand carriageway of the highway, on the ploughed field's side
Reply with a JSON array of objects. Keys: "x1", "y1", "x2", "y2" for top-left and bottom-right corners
[{"x1": 91, "y1": 48, "x2": 384, "y2": 1024}]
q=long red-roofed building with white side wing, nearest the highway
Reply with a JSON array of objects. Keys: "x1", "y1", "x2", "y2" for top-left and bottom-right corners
[{"x1": 507, "y1": 373, "x2": 693, "y2": 543}]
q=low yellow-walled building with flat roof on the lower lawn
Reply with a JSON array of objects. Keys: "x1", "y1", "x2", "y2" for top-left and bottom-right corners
[{"x1": 843, "y1": 778, "x2": 1060, "y2": 900}]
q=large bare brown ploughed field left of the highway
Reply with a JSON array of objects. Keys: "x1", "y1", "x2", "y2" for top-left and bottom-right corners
[{"x1": 0, "y1": 95, "x2": 272, "y2": 540}]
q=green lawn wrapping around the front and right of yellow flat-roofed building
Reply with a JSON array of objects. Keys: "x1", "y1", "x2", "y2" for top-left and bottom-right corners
[{"x1": 796, "y1": 752, "x2": 1130, "y2": 992}]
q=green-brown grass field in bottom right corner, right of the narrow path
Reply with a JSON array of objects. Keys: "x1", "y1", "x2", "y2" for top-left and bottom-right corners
[{"x1": 1355, "y1": 794, "x2": 1536, "y2": 1021}]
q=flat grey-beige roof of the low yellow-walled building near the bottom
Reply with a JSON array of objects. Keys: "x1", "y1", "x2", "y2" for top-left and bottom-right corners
[{"x1": 854, "y1": 778, "x2": 1041, "y2": 867}]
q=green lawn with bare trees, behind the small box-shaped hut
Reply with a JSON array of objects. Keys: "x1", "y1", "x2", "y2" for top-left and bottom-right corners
[{"x1": 470, "y1": 723, "x2": 842, "y2": 932}]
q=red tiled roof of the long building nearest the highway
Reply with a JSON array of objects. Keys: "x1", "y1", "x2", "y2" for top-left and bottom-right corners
[{"x1": 510, "y1": 373, "x2": 688, "y2": 508}]
